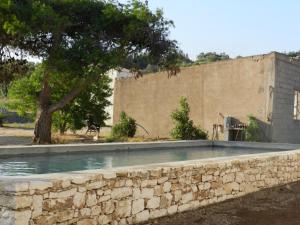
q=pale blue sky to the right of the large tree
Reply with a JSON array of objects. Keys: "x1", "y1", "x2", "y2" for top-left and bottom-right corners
[{"x1": 133, "y1": 0, "x2": 300, "y2": 59}]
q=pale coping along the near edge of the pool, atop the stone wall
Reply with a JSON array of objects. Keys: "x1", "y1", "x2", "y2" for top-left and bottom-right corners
[{"x1": 0, "y1": 149, "x2": 300, "y2": 185}]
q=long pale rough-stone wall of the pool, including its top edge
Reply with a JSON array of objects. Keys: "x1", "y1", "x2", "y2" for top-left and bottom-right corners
[{"x1": 0, "y1": 150, "x2": 300, "y2": 225}]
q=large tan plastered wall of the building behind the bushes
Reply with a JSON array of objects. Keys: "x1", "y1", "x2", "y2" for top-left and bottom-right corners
[{"x1": 114, "y1": 53, "x2": 275, "y2": 140}]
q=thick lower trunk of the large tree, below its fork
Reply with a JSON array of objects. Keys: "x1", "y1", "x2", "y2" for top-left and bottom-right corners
[{"x1": 33, "y1": 109, "x2": 52, "y2": 144}]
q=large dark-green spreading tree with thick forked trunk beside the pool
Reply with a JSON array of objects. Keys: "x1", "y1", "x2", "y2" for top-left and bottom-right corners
[{"x1": 0, "y1": 0, "x2": 177, "y2": 144}]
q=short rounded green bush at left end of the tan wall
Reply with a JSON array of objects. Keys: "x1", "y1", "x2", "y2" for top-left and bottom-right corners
[{"x1": 111, "y1": 112, "x2": 137, "y2": 139}]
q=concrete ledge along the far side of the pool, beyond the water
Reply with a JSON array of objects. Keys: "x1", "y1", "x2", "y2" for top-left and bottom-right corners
[{"x1": 0, "y1": 140, "x2": 300, "y2": 157}]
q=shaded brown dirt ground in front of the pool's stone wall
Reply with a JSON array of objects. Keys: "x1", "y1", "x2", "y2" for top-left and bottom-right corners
[{"x1": 143, "y1": 182, "x2": 300, "y2": 225}]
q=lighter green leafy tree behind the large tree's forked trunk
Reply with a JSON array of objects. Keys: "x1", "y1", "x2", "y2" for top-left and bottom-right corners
[{"x1": 9, "y1": 64, "x2": 112, "y2": 134}]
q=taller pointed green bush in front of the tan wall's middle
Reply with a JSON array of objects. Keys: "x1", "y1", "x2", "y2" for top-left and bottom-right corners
[{"x1": 171, "y1": 97, "x2": 208, "y2": 140}]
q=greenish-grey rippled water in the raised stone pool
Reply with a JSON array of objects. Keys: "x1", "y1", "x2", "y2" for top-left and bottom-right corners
[{"x1": 0, "y1": 147, "x2": 279, "y2": 176}]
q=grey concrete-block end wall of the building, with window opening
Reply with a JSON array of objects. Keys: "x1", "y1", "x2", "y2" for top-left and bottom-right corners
[{"x1": 272, "y1": 53, "x2": 300, "y2": 143}]
